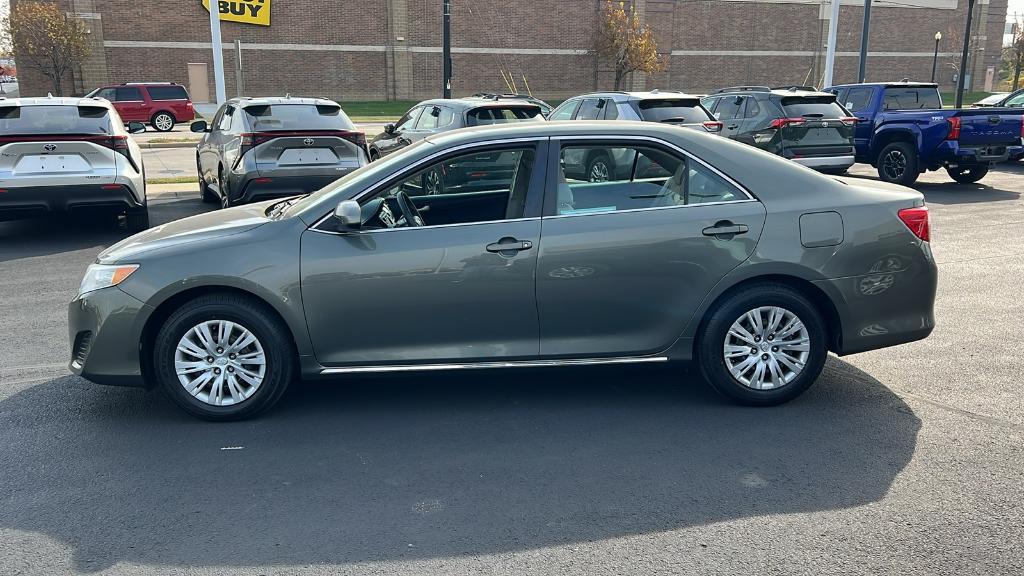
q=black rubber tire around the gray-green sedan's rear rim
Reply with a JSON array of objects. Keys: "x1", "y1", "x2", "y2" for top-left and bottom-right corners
[{"x1": 696, "y1": 283, "x2": 828, "y2": 406}]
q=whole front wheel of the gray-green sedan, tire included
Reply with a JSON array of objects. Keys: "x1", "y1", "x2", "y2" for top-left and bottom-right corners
[{"x1": 153, "y1": 294, "x2": 295, "y2": 420}]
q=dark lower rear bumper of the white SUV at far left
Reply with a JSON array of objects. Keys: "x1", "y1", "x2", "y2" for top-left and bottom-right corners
[{"x1": 0, "y1": 182, "x2": 145, "y2": 218}]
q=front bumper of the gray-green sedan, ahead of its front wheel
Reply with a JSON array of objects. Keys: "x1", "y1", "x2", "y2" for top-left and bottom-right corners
[{"x1": 68, "y1": 286, "x2": 153, "y2": 386}]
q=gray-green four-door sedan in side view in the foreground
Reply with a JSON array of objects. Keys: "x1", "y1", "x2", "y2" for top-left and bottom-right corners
[{"x1": 69, "y1": 122, "x2": 937, "y2": 419}]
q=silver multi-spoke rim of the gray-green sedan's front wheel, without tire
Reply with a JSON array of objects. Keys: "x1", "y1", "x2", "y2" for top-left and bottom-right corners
[{"x1": 174, "y1": 320, "x2": 266, "y2": 406}]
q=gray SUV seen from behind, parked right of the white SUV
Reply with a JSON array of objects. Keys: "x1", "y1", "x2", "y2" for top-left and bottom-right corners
[{"x1": 191, "y1": 96, "x2": 369, "y2": 208}]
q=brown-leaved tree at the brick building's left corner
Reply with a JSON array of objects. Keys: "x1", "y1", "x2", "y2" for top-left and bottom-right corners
[{"x1": 0, "y1": 2, "x2": 90, "y2": 96}]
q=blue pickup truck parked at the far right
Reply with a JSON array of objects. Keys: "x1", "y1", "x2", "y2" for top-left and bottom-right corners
[{"x1": 825, "y1": 81, "x2": 1024, "y2": 186}]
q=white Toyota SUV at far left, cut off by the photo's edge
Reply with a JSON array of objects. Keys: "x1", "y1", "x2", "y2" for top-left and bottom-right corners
[{"x1": 0, "y1": 97, "x2": 150, "y2": 232}]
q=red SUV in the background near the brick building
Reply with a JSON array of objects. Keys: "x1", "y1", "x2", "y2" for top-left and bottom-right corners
[{"x1": 86, "y1": 82, "x2": 196, "y2": 132}]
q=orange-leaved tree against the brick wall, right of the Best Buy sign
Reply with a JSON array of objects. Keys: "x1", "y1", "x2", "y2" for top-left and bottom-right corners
[{"x1": 593, "y1": 0, "x2": 665, "y2": 90}]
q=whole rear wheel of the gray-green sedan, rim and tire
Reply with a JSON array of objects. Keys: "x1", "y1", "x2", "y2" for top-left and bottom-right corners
[{"x1": 697, "y1": 283, "x2": 827, "y2": 406}]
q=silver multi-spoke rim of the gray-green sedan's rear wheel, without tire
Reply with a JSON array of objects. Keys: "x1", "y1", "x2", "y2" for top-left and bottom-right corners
[{"x1": 722, "y1": 306, "x2": 811, "y2": 389}]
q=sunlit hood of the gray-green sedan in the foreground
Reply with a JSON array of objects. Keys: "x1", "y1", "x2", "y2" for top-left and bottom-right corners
[{"x1": 98, "y1": 202, "x2": 272, "y2": 263}]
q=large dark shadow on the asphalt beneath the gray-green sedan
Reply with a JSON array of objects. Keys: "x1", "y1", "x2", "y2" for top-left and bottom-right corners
[{"x1": 0, "y1": 358, "x2": 921, "y2": 572}]
